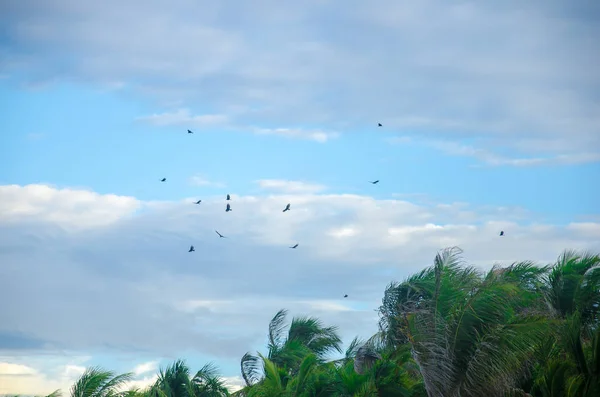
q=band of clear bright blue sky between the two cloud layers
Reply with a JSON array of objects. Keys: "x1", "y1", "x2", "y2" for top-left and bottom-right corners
[{"x1": 0, "y1": 78, "x2": 600, "y2": 223}]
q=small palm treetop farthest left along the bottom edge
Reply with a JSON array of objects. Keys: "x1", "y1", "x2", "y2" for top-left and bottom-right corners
[{"x1": 69, "y1": 367, "x2": 132, "y2": 397}]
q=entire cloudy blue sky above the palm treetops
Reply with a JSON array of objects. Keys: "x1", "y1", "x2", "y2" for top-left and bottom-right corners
[{"x1": 0, "y1": 0, "x2": 600, "y2": 394}]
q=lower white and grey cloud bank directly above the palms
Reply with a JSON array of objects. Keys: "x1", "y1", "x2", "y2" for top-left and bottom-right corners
[{"x1": 0, "y1": 184, "x2": 600, "y2": 393}]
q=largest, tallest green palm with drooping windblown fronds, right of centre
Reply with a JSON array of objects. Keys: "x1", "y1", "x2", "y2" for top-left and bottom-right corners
[{"x1": 381, "y1": 247, "x2": 548, "y2": 397}]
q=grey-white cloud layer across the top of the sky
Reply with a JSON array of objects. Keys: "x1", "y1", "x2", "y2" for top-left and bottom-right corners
[{"x1": 0, "y1": 0, "x2": 600, "y2": 159}]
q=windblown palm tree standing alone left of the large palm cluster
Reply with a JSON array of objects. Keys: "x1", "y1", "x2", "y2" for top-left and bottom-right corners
[{"x1": 241, "y1": 309, "x2": 342, "y2": 386}]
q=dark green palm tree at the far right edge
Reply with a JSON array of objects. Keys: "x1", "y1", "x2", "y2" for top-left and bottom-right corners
[{"x1": 531, "y1": 251, "x2": 600, "y2": 397}]
